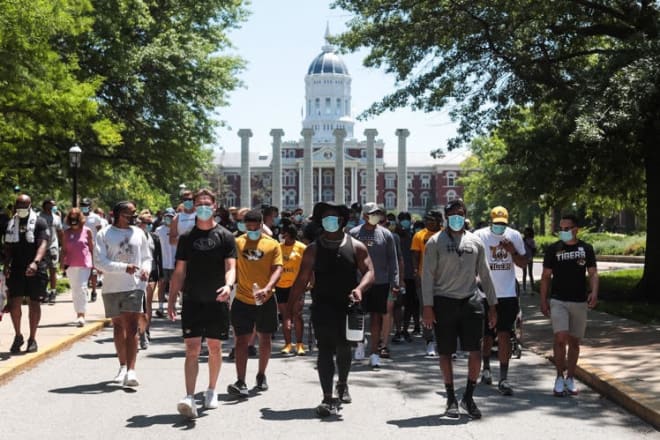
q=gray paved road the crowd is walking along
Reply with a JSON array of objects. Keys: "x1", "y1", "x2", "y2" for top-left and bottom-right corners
[{"x1": 0, "y1": 321, "x2": 660, "y2": 440}]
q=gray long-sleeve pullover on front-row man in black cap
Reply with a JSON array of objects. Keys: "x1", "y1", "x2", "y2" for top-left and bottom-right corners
[{"x1": 422, "y1": 230, "x2": 497, "y2": 306}]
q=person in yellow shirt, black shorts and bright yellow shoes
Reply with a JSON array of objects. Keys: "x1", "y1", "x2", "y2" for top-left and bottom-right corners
[{"x1": 275, "y1": 223, "x2": 307, "y2": 356}]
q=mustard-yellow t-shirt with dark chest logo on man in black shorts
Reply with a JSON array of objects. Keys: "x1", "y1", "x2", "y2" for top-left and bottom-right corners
[{"x1": 236, "y1": 234, "x2": 282, "y2": 304}]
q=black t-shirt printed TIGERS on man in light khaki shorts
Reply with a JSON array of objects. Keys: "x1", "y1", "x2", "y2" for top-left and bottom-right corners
[{"x1": 543, "y1": 240, "x2": 596, "y2": 302}]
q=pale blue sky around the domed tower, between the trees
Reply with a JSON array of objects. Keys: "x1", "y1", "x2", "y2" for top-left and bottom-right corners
[{"x1": 217, "y1": 0, "x2": 456, "y2": 164}]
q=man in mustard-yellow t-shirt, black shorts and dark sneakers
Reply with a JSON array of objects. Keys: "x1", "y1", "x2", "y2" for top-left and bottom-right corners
[{"x1": 227, "y1": 210, "x2": 282, "y2": 397}]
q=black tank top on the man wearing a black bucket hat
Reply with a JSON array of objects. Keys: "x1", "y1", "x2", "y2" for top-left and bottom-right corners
[{"x1": 312, "y1": 234, "x2": 358, "y2": 324}]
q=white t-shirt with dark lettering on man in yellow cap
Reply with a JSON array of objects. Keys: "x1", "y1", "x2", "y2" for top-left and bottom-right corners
[{"x1": 474, "y1": 226, "x2": 525, "y2": 298}]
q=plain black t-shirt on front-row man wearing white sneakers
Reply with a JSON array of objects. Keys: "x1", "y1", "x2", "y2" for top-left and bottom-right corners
[{"x1": 176, "y1": 225, "x2": 236, "y2": 302}]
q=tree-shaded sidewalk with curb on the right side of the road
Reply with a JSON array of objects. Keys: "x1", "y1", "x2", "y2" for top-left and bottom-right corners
[{"x1": 520, "y1": 294, "x2": 660, "y2": 429}]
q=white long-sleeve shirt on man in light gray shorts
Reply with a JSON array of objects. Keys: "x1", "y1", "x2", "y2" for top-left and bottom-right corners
[{"x1": 94, "y1": 225, "x2": 152, "y2": 294}]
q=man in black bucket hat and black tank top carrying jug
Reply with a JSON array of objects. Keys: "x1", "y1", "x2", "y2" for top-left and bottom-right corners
[{"x1": 287, "y1": 202, "x2": 374, "y2": 417}]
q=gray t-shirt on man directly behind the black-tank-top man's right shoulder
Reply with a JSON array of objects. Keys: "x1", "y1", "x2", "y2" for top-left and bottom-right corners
[{"x1": 349, "y1": 225, "x2": 399, "y2": 286}]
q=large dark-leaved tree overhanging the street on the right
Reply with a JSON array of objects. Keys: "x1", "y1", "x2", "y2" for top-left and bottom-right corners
[{"x1": 335, "y1": 0, "x2": 660, "y2": 301}]
